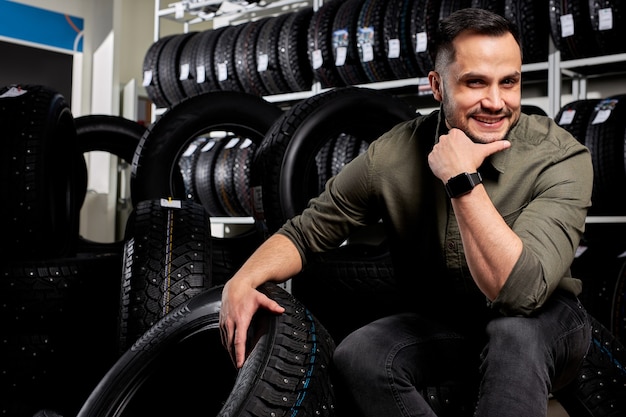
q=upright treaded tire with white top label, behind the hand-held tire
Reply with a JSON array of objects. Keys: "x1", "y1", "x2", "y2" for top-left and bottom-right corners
[{"x1": 119, "y1": 200, "x2": 212, "y2": 352}]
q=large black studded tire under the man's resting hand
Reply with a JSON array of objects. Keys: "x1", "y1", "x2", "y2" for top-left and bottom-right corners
[{"x1": 78, "y1": 284, "x2": 335, "y2": 417}]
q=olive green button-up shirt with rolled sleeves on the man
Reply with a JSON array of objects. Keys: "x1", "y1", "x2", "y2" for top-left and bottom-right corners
[{"x1": 278, "y1": 110, "x2": 593, "y2": 315}]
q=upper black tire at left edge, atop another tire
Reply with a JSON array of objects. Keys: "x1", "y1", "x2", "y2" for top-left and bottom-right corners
[{"x1": 0, "y1": 85, "x2": 84, "y2": 259}]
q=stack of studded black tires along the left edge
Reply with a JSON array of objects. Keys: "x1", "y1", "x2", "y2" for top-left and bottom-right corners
[{"x1": 0, "y1": 85, "x2": 130, "y2": 416}]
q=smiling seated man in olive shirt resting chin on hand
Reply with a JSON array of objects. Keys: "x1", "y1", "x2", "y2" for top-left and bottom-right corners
[{"x1": 220, "y1": 9, "x2": 593, "y2": 417}]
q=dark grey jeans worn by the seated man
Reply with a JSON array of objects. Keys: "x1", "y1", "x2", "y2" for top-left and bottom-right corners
[{"x1": 333, "y1": 292, "x2": 591, "y2": 417}]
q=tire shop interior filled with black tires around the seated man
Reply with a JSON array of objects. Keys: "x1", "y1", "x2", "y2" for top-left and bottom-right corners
[{"x1": 0, "y1": 0, "x2": 626, "y2": 417}]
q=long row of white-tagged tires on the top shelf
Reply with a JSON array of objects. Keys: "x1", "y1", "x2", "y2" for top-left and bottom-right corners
[{"x1": 143, "y1": 0, "x2": 626, "y2": 108}]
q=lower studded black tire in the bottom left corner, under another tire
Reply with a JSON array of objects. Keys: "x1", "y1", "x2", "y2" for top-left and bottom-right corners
[{"x1": 0, "y1": 252, "x2": 122, "y2": 417}]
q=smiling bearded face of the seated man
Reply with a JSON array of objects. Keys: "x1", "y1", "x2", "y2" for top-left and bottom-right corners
[{"x1": 431, "y1": 33, "x2": 522, "y2": 143}]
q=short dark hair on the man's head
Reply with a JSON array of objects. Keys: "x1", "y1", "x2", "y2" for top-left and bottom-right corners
[{"x1": 434, "y1": 7, "x2": 522, "y2": 70}]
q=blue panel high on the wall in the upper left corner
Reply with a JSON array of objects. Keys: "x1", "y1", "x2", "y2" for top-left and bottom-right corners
[{"x1": 0, "y1": 0, "x2": 83, "y2": 52}]
